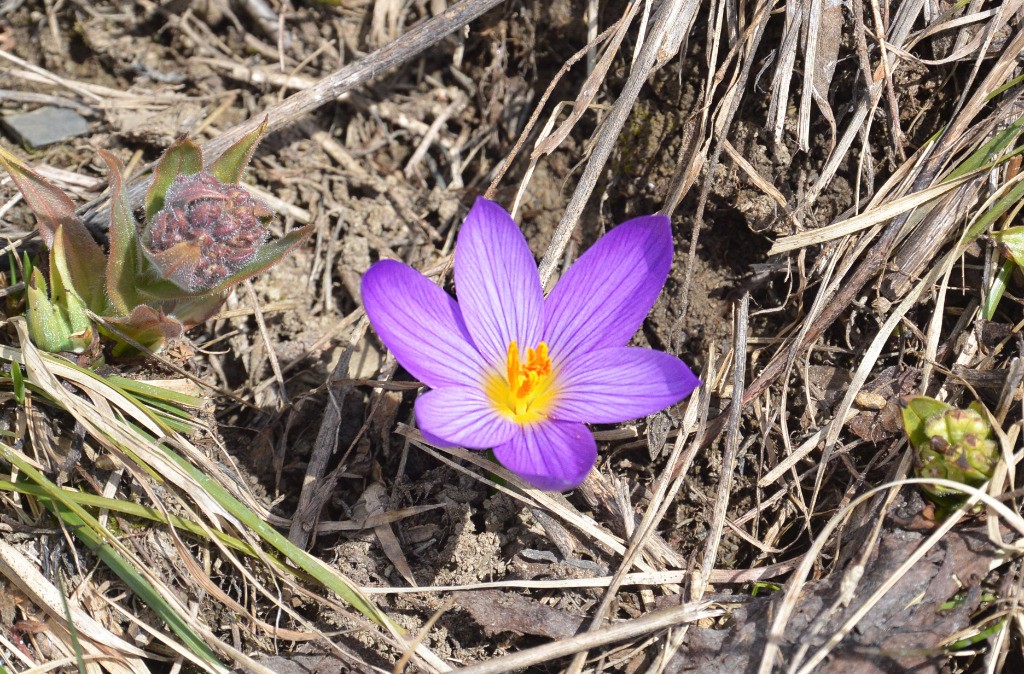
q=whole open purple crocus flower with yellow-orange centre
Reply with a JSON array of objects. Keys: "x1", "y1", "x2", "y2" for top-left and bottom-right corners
[{"x1": 362, "y1": 199, "x2": 700, "y2": 491}]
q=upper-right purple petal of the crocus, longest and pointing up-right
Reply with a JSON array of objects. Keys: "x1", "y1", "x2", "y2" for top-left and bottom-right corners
[{"x1": 544, "y1": 215, "x2": 672, "y2": 364}]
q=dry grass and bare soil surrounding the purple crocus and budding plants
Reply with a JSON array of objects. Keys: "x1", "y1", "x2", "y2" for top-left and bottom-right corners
[{"x1": 0, "y1": 0, "x2": 1024, "y2": 674}]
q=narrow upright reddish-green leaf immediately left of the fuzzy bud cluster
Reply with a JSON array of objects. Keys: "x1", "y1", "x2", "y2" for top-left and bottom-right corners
[{"x1": 98, "y1": 150, "x2": 142, "y2": 315}]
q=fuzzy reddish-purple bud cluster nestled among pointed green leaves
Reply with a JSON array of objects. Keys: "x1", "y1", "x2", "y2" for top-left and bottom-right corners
[{"x1": 145, "y1": 171, "x2": 273, "y2": 292}]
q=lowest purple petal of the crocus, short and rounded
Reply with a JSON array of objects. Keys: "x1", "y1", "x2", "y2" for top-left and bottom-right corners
[{"x1": 495, "y1": 419, "x2": 597, "y2": 492}]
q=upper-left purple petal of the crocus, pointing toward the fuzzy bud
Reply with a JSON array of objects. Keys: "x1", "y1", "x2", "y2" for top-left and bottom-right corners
[{"x1": 362, "y1": 260, "x2": 484, "y2": 387}]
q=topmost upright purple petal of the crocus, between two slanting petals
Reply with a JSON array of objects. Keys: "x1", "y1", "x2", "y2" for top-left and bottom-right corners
[{"x1": 455, "y1": 199, "x2": 544, "y2": 366}]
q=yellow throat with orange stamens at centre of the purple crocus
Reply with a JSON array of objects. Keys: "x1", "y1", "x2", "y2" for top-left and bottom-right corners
[{"x1": 484, "y1": 341, "x2": 556, "y2": 425}]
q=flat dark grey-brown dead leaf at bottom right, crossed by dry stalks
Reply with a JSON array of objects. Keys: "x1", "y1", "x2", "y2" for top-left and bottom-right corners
[{"x1": 666, "y1": 526, "x2": 997, "y2": 674}]
